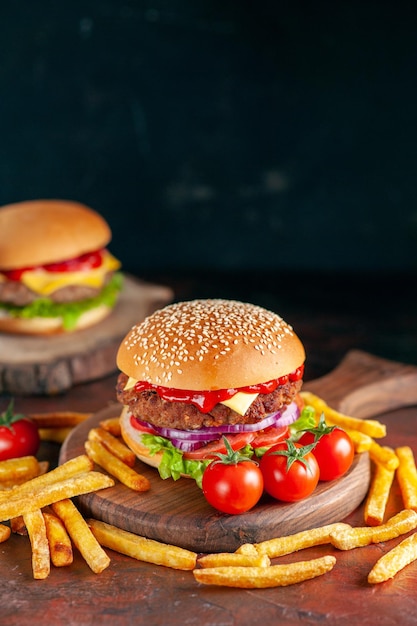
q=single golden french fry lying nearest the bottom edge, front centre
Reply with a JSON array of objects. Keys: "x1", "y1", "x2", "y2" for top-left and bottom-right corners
[{"x1": 193, "y1": 555, "x2": 336, "y2": 589}]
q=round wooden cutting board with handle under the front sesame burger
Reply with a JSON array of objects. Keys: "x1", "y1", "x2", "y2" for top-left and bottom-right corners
[{"x1": 60, "y1": 351, "x2": 417, "y2": 552}]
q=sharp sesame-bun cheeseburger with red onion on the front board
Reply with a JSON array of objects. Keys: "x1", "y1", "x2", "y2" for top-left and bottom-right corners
[{"x1": 117, "y1": 299, "x2": 305, "y2": 482}]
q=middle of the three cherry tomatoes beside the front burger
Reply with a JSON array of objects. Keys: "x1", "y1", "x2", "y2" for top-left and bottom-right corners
[{"x1": 260, "y1": 439, "x2": 320, "y2": 502}]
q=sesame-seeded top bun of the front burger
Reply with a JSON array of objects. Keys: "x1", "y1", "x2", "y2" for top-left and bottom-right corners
[{"x1": 117, "y1": 299, "x2": 305, "y2": 391}]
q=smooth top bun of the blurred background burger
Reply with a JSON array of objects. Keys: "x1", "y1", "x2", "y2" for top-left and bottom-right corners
[{"x1": 0, "y1": 200, "x2": 111, "y2": 270}]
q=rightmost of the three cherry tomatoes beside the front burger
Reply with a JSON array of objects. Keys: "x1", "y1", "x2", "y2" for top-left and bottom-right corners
[{"x1": 299, "y1": 418, "x2": 355, "y2": 480}]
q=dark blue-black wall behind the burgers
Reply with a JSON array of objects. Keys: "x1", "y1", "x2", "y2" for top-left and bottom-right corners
[{"x1": 0, "y1": 0, "x2": 417, "y2": 275}]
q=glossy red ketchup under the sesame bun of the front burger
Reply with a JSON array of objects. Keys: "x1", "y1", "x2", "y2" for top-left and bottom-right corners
[{"x1": 135, "y1": 364, "x2": 304, "y2": 413}]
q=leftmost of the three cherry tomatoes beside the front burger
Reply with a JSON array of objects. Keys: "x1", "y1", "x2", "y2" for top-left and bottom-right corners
[{"x1": 202, "y1": 461, "x2": 263, "y2": 514}]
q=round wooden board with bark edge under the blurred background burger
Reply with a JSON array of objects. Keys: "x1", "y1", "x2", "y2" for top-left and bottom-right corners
[{"x1": 0, "y1": 275, "x2": 173, "y2": 395}]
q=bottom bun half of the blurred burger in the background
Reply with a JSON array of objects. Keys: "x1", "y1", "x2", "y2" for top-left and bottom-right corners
[{"x1": 0, "y1": 304, "x2": 112, "y2": 335}]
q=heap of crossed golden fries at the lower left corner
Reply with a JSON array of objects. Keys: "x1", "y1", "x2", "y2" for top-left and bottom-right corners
[{"x1": 0, "y1": 454, "x2": 114, "y2": 579}]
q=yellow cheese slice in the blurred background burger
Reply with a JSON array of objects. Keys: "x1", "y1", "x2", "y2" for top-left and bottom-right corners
[{"x1": 13, "y1": 251, "x2": 121, "y2": 296}]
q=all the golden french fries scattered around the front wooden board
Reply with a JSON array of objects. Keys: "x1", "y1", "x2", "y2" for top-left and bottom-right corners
[{"x1": 0, "y1": 392, "x2": 417, "y2": 588}]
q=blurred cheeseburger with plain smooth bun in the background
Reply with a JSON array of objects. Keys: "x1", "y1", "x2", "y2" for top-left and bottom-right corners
[{"x1": 0, "y1": 200, "x2": 122, "y2": 335}]
